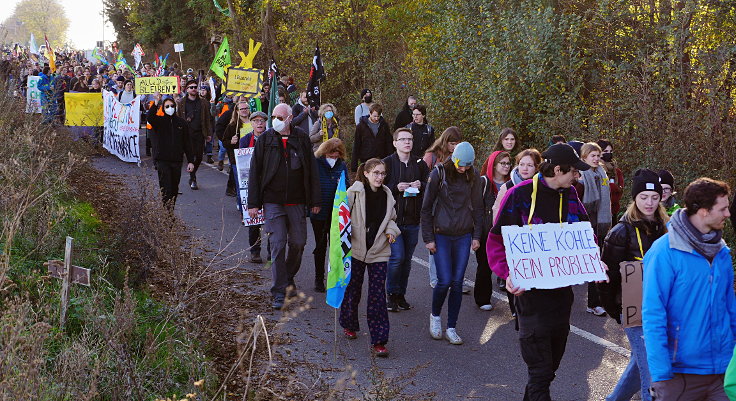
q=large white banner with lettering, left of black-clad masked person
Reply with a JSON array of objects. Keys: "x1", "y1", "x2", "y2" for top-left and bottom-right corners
[{"x1": 102, "y1": 91, "x2": 141, "y2": 163}]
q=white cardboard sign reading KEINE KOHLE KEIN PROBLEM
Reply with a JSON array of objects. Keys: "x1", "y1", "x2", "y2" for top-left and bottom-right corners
[{"x1": 501, "y1": 221, "x2": 607, "y2": 290}]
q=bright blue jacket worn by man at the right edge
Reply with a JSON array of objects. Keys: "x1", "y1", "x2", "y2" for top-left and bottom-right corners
[{"x1": 642, "y1": 224, "x2": 736, "y2": 382}]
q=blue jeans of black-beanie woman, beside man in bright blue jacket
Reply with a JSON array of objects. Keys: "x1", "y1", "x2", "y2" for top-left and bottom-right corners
[{"x1": 606, "y1": 326, "x2": 652, "y2": 401}]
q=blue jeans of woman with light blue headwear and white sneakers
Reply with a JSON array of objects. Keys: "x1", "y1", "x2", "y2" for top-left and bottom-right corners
[{"x1": 432, "y1": 233, "x2": 473, "y2": 329}]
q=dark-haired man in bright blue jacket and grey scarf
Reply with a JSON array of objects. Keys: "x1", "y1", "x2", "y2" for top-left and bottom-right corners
[{"x1": 642, "y1": 178, "x2": 736, "y2": 401}]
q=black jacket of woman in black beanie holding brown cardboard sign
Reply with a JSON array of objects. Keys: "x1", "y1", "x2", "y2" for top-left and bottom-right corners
[{"x1": 598, "y1": 216, "x2": 665, "y2": 324}]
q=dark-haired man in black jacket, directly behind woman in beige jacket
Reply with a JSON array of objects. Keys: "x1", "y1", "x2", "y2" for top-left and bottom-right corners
[{"x1": 350, "y1": 103, "x2": 394, "y2": 171}]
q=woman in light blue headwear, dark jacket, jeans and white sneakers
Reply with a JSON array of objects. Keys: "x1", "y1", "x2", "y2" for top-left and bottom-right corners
[{"x1": 420, "y1": 142, "x2": 483, "y2": 345}]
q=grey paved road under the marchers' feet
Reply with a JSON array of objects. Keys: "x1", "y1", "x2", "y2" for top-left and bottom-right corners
[{"x1": 94, "y1": 135, "x2": 628, "y2": 401}]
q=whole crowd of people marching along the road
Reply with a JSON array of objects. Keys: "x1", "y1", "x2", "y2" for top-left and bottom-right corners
[{"x1": 7, "y1": 43, "x2": 736, "y2": 401}]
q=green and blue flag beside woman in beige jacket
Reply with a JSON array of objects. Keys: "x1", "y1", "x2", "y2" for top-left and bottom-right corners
[{"x1": 326, "y1": 170, "x2": 353, "y2": 308}]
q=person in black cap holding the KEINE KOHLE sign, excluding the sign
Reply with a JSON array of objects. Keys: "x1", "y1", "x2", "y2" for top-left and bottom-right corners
[{"x1": 486, "y1": 144, "x2": 590, "y2": 401}]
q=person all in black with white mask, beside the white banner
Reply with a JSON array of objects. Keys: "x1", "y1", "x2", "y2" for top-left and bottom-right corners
[{"x1": 147, "y1": 93, "x2": 194, "y2": 206}]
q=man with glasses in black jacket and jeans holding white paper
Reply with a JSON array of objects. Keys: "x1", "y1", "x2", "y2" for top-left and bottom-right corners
[{"x1": 383, "y1": 128, "x2": 429, "y2": 312}]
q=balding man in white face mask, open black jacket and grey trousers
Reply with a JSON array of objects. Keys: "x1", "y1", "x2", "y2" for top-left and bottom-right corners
[{"x1": 248, "y1": 104, "x2": 321, "y2": 309}]
